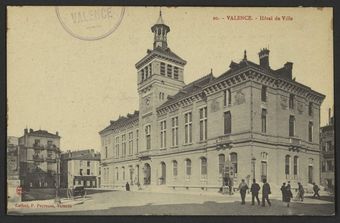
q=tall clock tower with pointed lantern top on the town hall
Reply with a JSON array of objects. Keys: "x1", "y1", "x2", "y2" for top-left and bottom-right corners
[{"x1": 135, "y1": 11, "x2": 186, "y2": 151}]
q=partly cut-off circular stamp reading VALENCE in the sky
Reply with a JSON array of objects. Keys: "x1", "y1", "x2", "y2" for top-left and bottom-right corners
[{"x1": 55, "y1": 6, "x2": 125, "y2": 40}]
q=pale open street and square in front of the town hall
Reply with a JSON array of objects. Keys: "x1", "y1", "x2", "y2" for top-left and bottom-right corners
[{"x1": 8, "y1": 191, "x2": 334, "y2": 215}]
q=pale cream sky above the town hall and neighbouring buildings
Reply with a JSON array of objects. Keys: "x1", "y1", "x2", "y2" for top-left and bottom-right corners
[{"x1": 7, "y1": 6, "x2": 334, "y2": 151}]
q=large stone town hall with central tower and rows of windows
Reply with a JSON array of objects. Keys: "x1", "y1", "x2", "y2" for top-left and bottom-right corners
[{"x1": 100, "y1": 11, "x2": 325, "y2": 191}]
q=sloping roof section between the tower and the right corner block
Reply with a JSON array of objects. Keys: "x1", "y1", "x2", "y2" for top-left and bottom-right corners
[{"x1": 158, "y1": 73, "x2": 215, "y2": 109}]
